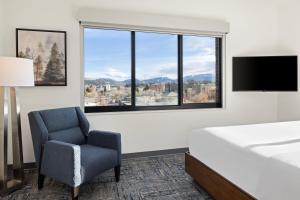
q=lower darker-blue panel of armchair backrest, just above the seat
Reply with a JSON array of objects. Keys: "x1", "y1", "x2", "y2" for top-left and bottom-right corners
[{"x1": 48, "y1": 127, "x2": 85, "y2": 145}]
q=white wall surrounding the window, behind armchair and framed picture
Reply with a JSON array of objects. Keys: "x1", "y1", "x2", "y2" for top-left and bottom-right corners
[{"x1": 1, "y1": 0, "x2": 278, "y2": 162}]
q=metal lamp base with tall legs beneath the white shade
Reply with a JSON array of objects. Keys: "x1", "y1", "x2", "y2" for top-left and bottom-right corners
[{"x1": 0, "y1": 87, "x2": 24, "y2": 196}]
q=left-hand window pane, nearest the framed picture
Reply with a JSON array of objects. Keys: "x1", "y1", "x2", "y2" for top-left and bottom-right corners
[{"x1": 84, "y1": 28, "x2": 131, "y2": 106}]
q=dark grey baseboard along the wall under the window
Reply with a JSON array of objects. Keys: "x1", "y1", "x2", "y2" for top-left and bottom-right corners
[{"x1": 14, "y1": 148, "x2": 188, "y2": 169}]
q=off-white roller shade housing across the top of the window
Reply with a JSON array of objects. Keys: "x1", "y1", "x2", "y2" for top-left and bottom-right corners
[{"x1": 78, "y1": 9, "x2": 229, "y2": 36}]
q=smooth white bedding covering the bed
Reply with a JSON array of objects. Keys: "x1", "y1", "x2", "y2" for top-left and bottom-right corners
[{"x1": 189, "y1": 121, "x2": 300, "y2": 200}]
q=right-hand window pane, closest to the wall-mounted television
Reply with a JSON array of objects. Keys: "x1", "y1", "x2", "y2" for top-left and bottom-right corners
[{"x1": 183, "y1": 36, "x2": 217, "y2": 104}]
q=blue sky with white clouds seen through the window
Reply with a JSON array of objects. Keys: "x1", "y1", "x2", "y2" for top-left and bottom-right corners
[{"x1": 84, "y1": 28, "x2": 215, "y2": 81}]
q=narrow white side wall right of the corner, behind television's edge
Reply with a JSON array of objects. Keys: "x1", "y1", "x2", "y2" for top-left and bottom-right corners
[{"x1": 278, "y1": 0, "x2": 300, "y2": 121}]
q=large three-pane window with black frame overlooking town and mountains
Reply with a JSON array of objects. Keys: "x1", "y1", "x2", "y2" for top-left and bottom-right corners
[{"x1": 83, "y1": 28, "x2": 222, "y2": 112}]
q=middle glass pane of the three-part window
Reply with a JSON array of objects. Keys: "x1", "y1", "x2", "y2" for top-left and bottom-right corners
[{"x1": 135, "y1": 32, "x2": 178, "y2": 106}]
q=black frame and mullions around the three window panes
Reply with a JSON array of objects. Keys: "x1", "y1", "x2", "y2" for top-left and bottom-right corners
[{"x1": 82, "y1": 26, "x2": 225, "y2": 113}]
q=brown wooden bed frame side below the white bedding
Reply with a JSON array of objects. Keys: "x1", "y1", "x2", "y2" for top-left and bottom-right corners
[{"x1": 185, "y1": 152, "x2": 255, "y2": 200}]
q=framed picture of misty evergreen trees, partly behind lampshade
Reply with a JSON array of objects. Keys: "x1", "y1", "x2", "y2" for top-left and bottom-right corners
[{"x1": 16, "y1": 28, "x2": 67, "y2": 86}]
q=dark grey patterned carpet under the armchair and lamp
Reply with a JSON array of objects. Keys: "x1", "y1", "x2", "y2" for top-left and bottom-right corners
[{"x1": 0, "y1": 154, "x2": 212, "y2": 200}]
